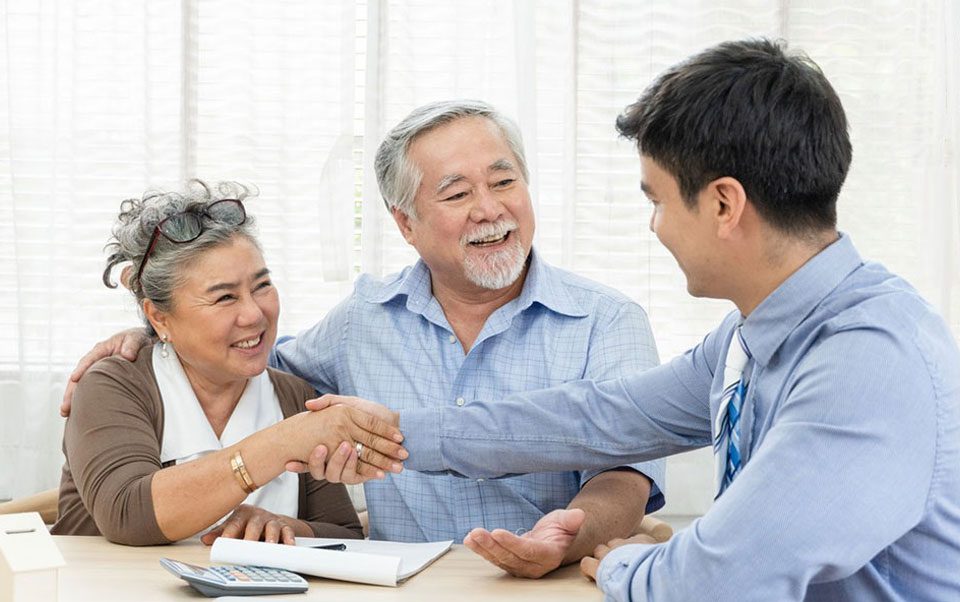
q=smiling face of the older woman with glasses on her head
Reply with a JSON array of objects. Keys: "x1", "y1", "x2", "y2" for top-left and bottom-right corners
[{"x1": 155, "y1": 236, "x2": 280, "y2": 383}]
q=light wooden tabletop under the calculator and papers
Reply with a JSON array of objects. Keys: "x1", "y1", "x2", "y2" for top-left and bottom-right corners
[{"x1": 54, "y1": 536, "x2": 603, "y2": 602}]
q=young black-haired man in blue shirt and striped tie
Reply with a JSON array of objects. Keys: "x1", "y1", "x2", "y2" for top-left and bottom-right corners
[{"x1": 344, "y1": 41, "x2": 960, "y2": 601}]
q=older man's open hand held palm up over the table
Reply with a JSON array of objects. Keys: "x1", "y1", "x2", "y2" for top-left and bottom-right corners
[{"x1": 463, "y1": 509, "x2": 586, "y2": 579}]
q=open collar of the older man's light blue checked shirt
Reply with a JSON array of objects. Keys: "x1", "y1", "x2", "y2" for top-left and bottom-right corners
[{"x1": 371, "y1": 249, "x2": 588, "y2": 317}]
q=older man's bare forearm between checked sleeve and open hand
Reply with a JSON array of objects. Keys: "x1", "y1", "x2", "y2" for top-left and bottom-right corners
[{"x1": 563, "y1": 469, "x2": 651, "y2": 564}]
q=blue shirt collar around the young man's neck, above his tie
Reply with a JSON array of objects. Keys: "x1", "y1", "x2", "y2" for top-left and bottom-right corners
[{"x1": 742, "y1": 233, "x2": 863, "y2": 365}]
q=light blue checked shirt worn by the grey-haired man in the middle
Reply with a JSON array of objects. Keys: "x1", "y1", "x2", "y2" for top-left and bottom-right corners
[{"x1": 271, "y1": 253, "x2": 664, "y2": 541}]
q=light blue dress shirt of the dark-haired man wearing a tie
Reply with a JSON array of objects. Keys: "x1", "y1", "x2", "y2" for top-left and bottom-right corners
[{"x1": 400, "y1": 236, "x2": 960, "y2": 602}]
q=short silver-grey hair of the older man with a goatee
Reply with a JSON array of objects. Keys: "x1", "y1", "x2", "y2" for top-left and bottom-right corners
[{"x1": 374, "y1": 100, "x2": 530, "y2": 217}]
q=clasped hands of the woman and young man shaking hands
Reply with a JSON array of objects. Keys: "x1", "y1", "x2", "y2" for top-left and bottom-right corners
[{"x1": 286, "y1": 395, "x2": 409, "y2": 485}]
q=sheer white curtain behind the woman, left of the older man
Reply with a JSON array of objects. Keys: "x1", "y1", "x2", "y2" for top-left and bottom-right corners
[{"x1": 0, "y1": 0, "x2": 358, "y2": 499}]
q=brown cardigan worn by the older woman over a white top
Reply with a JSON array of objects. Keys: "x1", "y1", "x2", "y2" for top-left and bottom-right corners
[{"x1": 51, "y1": 345, "x2": 363, "y2": 545}]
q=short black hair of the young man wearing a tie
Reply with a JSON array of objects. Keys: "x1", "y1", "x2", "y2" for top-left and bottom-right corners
[{"x1": 617, "y1": 39, "x2": 853, "y2": 235}]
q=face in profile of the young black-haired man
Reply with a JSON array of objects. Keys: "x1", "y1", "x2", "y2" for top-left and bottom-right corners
[{"x1": 640, "y1": 155, "x2": 716, "y2": 297}]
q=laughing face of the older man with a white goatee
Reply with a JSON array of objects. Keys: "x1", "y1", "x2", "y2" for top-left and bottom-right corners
[{"x1": 394, "y1": 117, "x2": 535, "y2": 292}]
